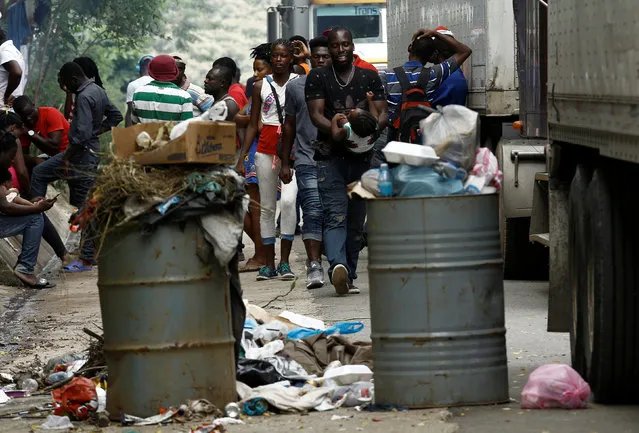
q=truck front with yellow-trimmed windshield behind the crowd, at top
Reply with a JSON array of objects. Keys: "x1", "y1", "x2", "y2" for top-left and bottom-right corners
[{"x1": 267, "y1": 0, "x2": 387, "y2": 70}]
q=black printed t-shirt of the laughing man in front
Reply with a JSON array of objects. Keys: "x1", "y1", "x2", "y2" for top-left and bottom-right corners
[{"x1": 304, "y1": 66, "x2": 386, "y2": 159}]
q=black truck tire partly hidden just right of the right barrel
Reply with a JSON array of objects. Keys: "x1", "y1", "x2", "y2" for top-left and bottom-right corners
[{"x1": 503, "y1": 217, "x2": 549, "y2": 281}]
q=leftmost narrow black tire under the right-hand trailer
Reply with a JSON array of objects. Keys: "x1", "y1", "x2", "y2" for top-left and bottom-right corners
[{"x1": 568, "y1": 166, "x2": 589, "y2": 380}]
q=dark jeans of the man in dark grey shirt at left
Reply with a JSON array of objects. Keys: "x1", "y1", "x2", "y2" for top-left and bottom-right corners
[{"x1": 31, "y1": 151, "x2": 99, "y2": 262}]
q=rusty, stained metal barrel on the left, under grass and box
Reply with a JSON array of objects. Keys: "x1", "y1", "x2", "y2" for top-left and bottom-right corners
[{"x1": 98, "y1": 222, "x2": 236, "y2": 419}]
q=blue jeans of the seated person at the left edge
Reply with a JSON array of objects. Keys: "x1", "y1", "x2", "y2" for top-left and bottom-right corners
[{"x1": 0, "y1": 213, "x2": 44, "y2": 275}]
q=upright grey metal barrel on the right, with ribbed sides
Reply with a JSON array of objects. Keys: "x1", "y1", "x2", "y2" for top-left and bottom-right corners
[{"x1": 367, "y1": 195, "x2": 508, "y2": 408}]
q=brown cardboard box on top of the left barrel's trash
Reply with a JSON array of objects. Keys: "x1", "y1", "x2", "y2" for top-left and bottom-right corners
[{"x1": 111, "y1": 121, "x2": 237, "y2": 165}]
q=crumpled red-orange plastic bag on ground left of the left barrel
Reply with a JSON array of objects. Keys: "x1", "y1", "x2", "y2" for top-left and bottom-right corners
[{"x1": 51, "y1": 377, "x2": 98, "y2": 420}]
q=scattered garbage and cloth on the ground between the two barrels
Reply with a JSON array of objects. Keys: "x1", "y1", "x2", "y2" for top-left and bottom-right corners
[{"x1": 237, "y1": 304, "x2": 374, "y2": 415}]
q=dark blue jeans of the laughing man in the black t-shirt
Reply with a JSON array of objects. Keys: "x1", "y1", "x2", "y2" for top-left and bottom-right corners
[{"x1": 317, "y1": 157, "x2": 370, "y2": 281}]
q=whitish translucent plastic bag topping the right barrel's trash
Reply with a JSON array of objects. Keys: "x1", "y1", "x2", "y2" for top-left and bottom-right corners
[{"x1": 419, "y1": 105, "x2": 479, "y2": 171}]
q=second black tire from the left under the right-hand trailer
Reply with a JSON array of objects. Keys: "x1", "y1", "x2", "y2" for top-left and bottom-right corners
[{"x1": 582, "y1": 169, "x2": 623, "y2": 403}]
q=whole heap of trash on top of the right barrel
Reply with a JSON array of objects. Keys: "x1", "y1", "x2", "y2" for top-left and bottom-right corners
[{"x1": 354, "y1": 105, "x2": 503, "y2": 198}]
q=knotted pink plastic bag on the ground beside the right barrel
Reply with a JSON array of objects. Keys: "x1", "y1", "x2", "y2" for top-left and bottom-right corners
[{"x1": 521, "y1": 364, "x2": 590, "y2": 409}]
